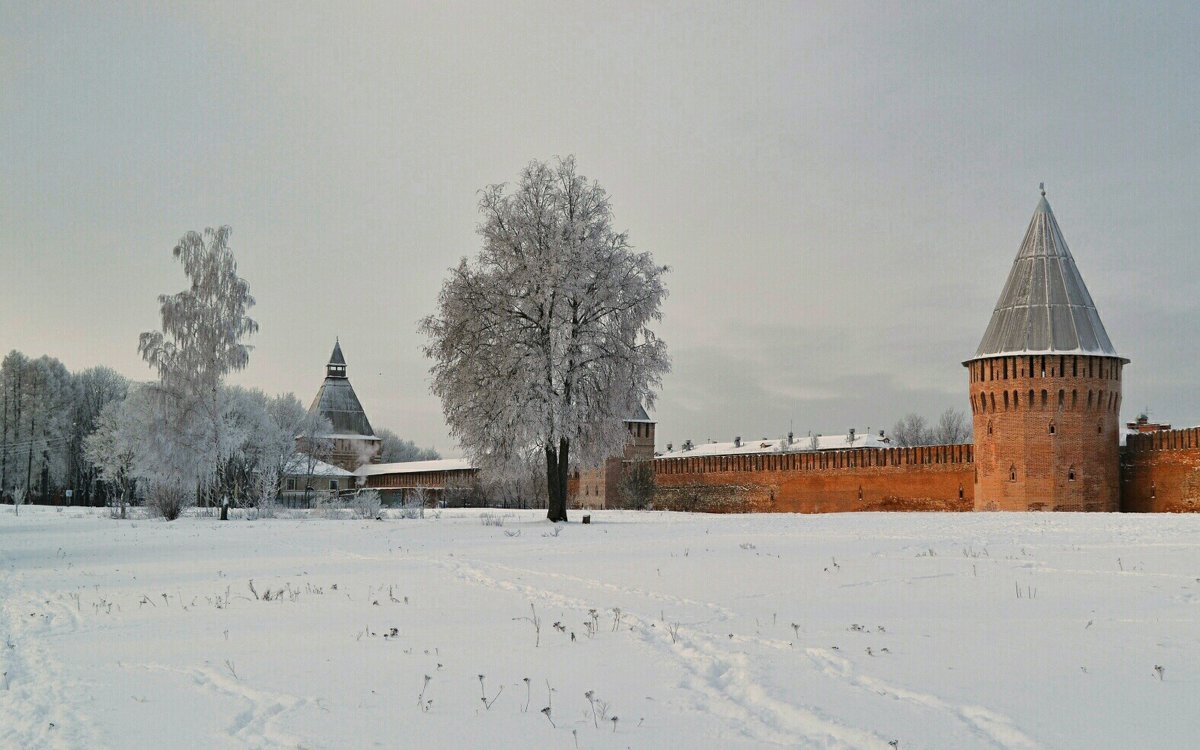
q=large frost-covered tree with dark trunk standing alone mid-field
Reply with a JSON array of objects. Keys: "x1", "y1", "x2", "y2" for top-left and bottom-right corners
[{"x1": 420, "y1": 157, "x2": 670, "y2": 521}]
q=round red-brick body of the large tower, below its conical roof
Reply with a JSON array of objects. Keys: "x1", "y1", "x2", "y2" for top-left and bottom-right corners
[{"x1": 967, "y1": 355, "x2": 1122, "y2": 511}]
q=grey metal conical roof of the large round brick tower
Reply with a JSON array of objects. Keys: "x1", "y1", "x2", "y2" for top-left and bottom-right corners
[{"x1": 967, "y1": 190, "x2": 1118, "y2": 361}]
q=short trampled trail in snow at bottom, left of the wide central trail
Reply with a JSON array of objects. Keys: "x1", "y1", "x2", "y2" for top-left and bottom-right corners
[{"x1": 135, "y1": 664, "x2": 308, "y2": 749}]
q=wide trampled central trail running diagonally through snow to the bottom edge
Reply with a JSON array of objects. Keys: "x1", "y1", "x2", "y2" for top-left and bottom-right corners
[{"x1": 430, "y1": 557, "x2": 889, "y2": 750}]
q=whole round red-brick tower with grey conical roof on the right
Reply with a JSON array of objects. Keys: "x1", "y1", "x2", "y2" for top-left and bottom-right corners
[{"x1": 962, "y1": 190, "x2": 1129, "y2": 511}]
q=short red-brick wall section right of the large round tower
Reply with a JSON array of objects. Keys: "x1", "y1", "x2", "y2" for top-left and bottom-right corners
[{"x1": 1121, "y1": 427, "x2": 1200, "y2": 512}]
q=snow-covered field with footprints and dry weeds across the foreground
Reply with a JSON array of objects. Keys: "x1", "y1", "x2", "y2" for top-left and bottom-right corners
[{"x1": 0, "y1": 506, "x2": 1200, "y2": 750}]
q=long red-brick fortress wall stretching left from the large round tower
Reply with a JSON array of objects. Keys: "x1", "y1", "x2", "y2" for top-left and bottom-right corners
[{"x1": 654, "y1": 445, "x2": 974, "y2": 512}]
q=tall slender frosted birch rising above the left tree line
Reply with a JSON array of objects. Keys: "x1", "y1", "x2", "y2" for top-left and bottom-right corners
[{"x1": 138, "y1": 227, "x2": 258, "y2": 518}]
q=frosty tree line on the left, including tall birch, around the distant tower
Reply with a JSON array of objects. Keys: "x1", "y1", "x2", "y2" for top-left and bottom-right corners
[{"x1": 7, "y1": 227, "x2": 437, "y2": 518}]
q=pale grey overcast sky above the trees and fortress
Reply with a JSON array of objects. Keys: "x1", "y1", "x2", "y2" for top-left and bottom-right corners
[{"x1": 0, "y1": 0, "x2": 1200, "y2": 455}]
